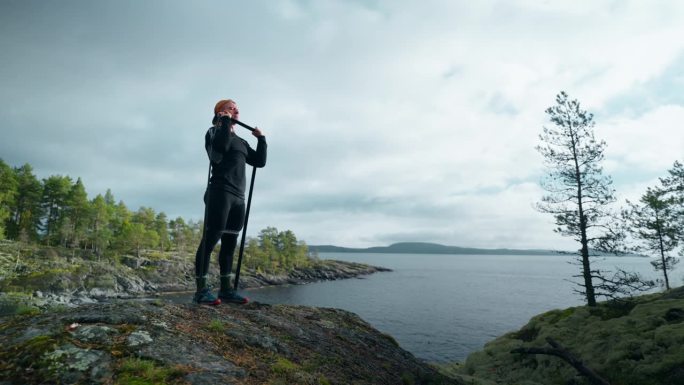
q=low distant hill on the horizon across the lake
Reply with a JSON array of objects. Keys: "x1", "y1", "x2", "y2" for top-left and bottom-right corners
[{"x1": 309, "y1": 242, "x2": 565, "y2": 255}]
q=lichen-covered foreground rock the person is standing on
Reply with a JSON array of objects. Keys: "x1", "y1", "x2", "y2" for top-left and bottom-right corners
[{"x1": 0, "y1": 300, "x2": 462, "y2": 385}]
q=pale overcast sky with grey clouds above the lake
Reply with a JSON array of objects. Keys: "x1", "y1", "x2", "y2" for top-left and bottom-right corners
[{"x1": 0, "y1": 0, "x2": 684, "y2": 249}]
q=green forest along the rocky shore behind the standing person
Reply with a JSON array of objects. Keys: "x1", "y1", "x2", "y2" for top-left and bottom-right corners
[{"x1": 0, "y1": 159, "x2": 310, "y2": 271}]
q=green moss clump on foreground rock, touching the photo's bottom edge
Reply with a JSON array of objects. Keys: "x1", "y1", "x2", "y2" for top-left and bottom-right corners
[{"x1": 115, "y1": 358, "x2": 186, "y2": 385}]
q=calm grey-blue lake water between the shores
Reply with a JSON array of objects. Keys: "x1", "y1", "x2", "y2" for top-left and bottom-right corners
[{"x1": 167, "y1": 253, "x2": 684, "y2": 362}]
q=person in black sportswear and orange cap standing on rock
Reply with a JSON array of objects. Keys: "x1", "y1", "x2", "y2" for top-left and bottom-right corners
[{"x1": 193, "y1": 99, "x2": 266, "y2": 305}]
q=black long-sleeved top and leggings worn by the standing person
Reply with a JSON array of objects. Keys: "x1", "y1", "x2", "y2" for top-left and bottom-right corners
[{"x1": 195, "y1": 121, "x2": 266, "y2": 277}]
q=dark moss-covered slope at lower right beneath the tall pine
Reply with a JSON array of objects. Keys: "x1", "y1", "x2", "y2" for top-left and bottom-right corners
[{"x1": 459, "y1": 288, "x2": 684, "y2": 385}]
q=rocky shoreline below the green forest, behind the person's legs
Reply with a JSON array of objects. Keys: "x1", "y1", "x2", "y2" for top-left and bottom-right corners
[{"x1": 0, "y1": 242, "x2": 389, "y2": 315}]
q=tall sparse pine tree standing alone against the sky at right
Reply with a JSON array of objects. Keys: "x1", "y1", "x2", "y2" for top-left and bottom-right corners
[{"x1": 537, "y1": 92, "x2": 630, "y2": 306}]
